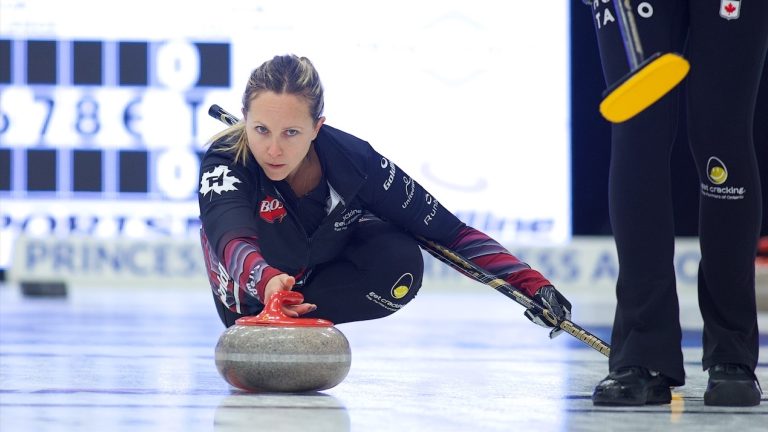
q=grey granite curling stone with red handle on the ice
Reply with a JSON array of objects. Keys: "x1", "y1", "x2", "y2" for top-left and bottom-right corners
[{"x1": 216, "y1": 291, "x2": 352, "y2": 393}]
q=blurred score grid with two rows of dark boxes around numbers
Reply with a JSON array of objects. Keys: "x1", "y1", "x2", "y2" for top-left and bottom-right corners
[{"x1": 0, "y1": 39, "x2": 231, "y2": 199}]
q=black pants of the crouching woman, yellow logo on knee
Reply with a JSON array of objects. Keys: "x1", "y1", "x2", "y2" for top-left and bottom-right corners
[{"x1": 213, "y1": 219, "x2": 424, "y2": 327}]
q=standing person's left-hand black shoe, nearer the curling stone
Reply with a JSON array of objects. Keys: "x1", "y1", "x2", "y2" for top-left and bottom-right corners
[{"x1": 592, "y1": 366, "x2": 672, "y2": 406}]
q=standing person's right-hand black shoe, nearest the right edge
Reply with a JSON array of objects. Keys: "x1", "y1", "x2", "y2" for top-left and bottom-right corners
[{"x1": 704, "y1": 363, "x2": 761, "y2": 406}]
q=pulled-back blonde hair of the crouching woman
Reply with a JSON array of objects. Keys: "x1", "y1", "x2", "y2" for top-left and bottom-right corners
[{"x1": 208, "y1": 54, "x2": 324, "y2": 164}]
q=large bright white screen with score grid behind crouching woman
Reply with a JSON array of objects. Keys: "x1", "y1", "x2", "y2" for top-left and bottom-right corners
[{"x1": 0, "y1": 0, "x2": 570, "y2": 269}]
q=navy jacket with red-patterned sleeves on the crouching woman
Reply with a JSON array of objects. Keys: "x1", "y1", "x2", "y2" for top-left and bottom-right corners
[{"x1": 198, "y1": 125, "x2": 550, "y2": 312}]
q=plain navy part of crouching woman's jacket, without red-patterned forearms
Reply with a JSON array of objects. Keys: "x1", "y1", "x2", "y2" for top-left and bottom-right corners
[{"x1": 199, "y1": 125, "x2": 464, "y2": 274}]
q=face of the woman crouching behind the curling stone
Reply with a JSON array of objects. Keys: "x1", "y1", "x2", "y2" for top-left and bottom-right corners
[{"x1": 243, "y1": 91, "x2": 325, "y2": 181}]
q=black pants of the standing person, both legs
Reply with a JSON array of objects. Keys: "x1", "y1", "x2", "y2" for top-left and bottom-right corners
[{"x1": 593, "y1": 0, "x2": 768, "y2": 385}]
